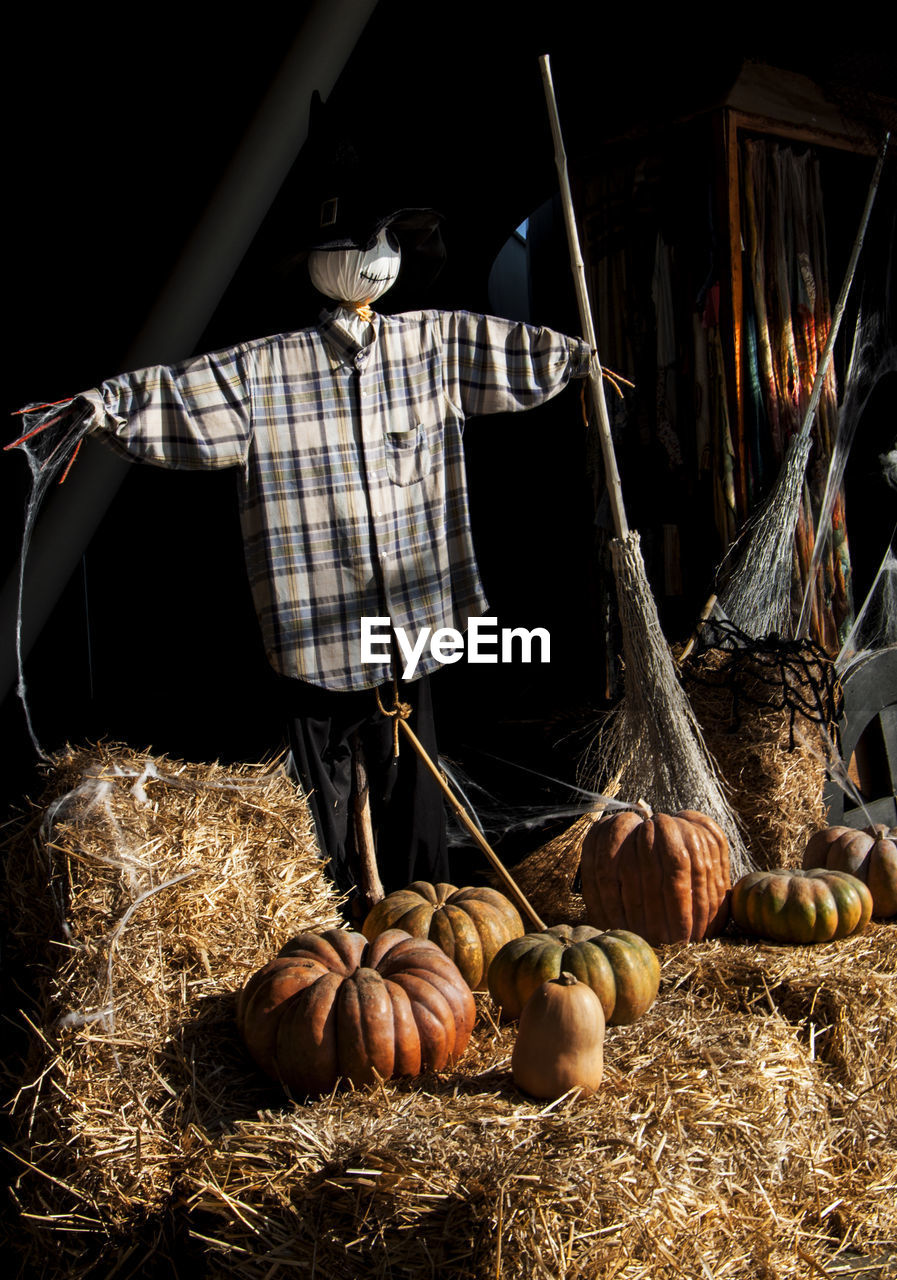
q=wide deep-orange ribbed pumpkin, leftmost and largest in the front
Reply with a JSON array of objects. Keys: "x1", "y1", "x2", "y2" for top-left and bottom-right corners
[{"x1": 237, "y1": 929, "x2": 476, "y2": 1094}]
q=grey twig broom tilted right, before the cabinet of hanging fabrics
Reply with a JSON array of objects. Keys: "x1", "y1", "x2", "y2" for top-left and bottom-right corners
[{"x1": 717, "y1": 133, "x2": 891, "y2": 637}]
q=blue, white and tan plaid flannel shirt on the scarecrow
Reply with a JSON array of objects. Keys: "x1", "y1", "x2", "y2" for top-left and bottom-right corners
[{"x1": 84, "y1": 311, "x2": 589, "y2": 690}]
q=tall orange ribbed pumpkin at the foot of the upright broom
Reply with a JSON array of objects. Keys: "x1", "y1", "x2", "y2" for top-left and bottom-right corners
[{"x1": 581, "y1": 805, "x2": 732, "y2": 946}]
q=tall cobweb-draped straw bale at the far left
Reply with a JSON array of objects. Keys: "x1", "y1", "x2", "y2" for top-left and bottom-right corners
[{"x1": 6, "y1": 746, "x2": 339, "y2": 1269}]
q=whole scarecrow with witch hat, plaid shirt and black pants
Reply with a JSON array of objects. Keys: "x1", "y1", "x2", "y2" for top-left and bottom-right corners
[{"x1": 13, "y1": 198, "x2": 590, "y2": 904}]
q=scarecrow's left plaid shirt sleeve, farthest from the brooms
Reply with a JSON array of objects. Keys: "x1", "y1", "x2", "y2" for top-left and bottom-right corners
[{"x1": 81, "y1": 346, "x2": 252, "y2": 470}]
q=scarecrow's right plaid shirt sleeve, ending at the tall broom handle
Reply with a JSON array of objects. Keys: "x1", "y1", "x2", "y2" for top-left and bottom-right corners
[{"x1": 443, "y1": 311, "x2": 590, "y2": 416}]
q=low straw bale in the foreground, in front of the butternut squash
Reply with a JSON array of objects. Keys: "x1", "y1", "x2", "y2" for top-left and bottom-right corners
[{"x1": 175, "y1": 927, "x2": 897, "y2": 1280}]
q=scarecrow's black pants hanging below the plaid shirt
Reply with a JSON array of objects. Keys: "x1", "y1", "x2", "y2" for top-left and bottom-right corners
[{"x1": 283, "y1": 676, "x2": 449, "y2": 893}]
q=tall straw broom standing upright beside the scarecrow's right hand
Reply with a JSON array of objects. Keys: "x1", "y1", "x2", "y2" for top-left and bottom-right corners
[{"x1": 539, "y1": 56, "x2": 754, "y2": 878}]
